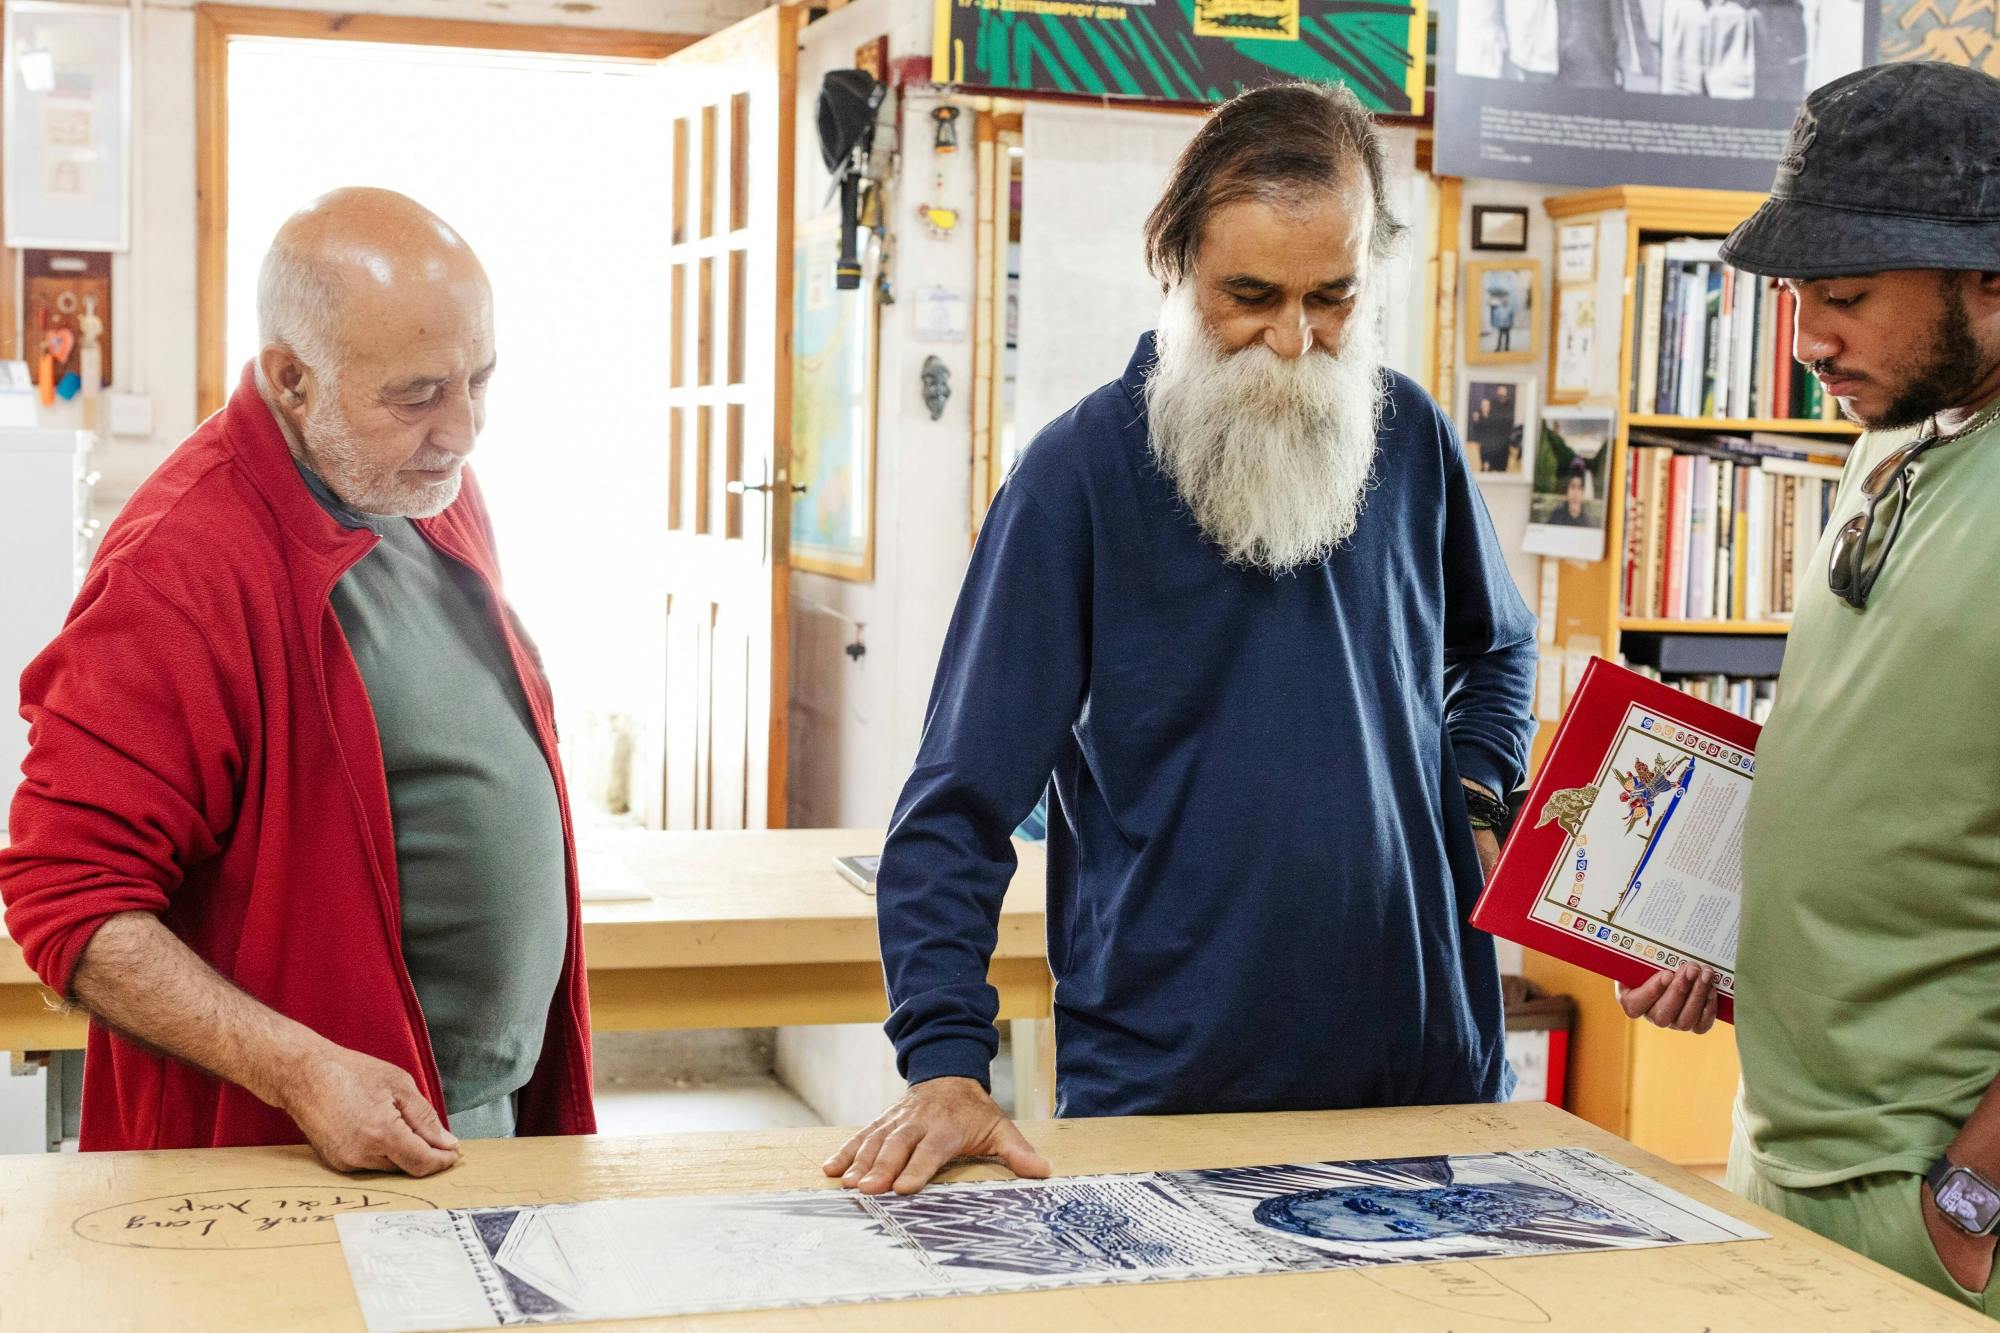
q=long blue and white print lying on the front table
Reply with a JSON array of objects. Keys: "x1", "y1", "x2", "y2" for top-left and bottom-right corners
[{"x1": 336, "y1": 1149, "x2": 1762, "y2": 1333}]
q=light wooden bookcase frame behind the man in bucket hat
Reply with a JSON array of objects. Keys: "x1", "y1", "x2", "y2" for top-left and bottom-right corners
[{"x1": 1524, "y1": 186, "x2": 1858, "y2": 1167}]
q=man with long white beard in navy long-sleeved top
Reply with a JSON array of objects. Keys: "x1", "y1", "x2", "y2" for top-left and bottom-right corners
[{"x1": 826, "y1": 84, "x2": 1534, "y2": 1193}]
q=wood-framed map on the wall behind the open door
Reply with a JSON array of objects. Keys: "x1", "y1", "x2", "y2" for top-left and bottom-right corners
[{"x1": 792, "y1": 226, "x2": 876, "y2": 580}]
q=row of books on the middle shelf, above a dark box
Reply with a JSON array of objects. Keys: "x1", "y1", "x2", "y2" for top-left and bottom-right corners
[{"x1": 1620, "y1": 430, "x2": 1850, "y2": 620}]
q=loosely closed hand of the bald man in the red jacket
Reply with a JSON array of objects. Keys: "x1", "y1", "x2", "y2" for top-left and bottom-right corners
[{"x1": 268, "y1": 1041, "x2": 458, "y2": 1175}]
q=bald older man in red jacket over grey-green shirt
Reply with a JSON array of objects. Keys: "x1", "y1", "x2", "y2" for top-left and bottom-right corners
[{"x1": 0, "y1": 190, "x2": 594, "y2": 1175}]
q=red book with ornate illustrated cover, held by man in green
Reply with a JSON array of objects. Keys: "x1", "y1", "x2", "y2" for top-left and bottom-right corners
[{"x1": 1472, "y1": 658, "x2": 1760, "y2": 1023}]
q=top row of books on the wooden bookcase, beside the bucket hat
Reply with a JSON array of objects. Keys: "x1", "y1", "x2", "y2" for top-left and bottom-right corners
[{"x1": 1630, "y1": 240, "x2": 1840, "y2": 420}]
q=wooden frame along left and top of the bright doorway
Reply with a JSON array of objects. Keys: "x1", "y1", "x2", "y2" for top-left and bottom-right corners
[{"x1": 194, "y1": 4, "x2": 706, "y2": 418}]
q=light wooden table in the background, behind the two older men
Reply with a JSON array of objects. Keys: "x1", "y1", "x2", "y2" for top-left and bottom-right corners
[{"x1": 0, "y1": 829, "x2": 1052, "y2": 1051}]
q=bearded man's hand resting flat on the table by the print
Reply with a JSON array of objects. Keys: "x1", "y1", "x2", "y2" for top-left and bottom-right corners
[{"x1": 822, "y1": 1079, "x2": 1050, "y2": 1195}]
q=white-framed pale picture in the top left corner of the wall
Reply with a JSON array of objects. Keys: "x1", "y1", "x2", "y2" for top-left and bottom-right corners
[{"x1": 0, "y1": 0, "x2": 132, "y2": 250}]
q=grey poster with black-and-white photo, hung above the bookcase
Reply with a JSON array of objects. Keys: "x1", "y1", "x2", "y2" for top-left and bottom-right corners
[{"x1": 1436, "y1": 0, "x2": 1880, "y2": 190}]
